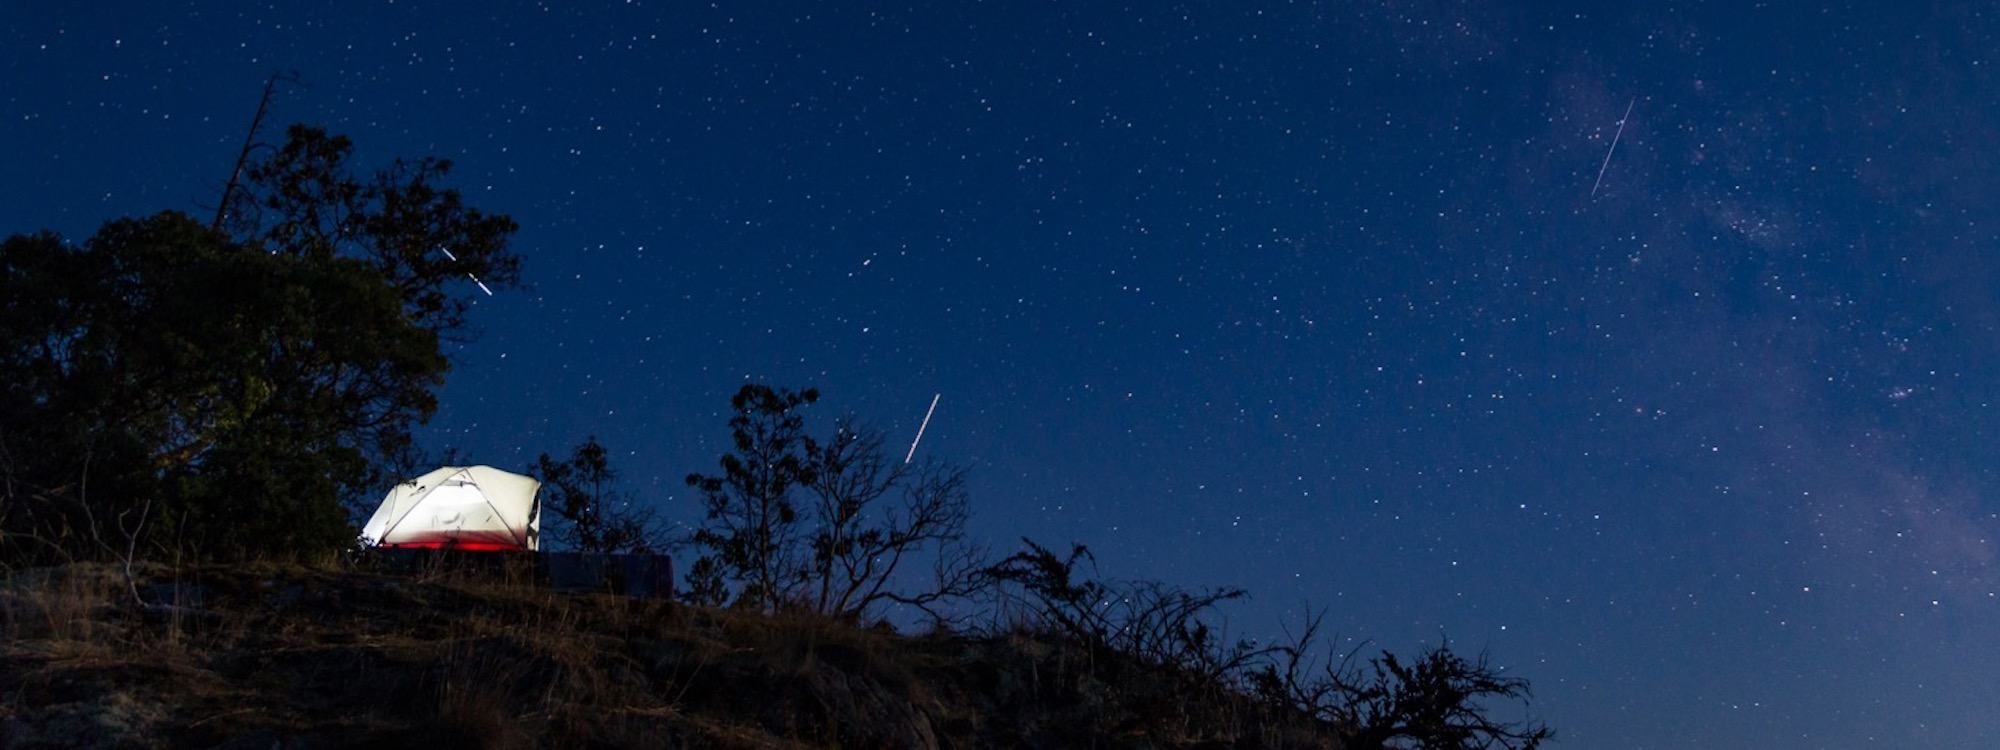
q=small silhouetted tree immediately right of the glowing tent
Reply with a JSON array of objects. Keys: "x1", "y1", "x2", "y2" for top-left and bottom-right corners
[{"x1": 530, "y1": 436, "x2": 654, "y2": 554}]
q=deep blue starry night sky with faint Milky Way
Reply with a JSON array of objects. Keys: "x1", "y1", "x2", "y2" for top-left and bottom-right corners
[{"x1": 0, "y1": 2, "x2": 2000, "y2": 748}]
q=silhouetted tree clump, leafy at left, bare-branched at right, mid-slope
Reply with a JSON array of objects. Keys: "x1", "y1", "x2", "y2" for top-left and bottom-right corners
[{"x1": 688, "y1": 384, "x2": 988, "y2": 620}]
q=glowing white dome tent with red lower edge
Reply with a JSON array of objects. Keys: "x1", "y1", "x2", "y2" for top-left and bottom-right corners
[{"x1": 362, "y1": 466, "x2": 542, "y2": 550}]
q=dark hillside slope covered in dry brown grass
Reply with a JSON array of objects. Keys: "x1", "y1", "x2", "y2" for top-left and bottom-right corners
[{"x1": 0, "y1": 564, "x2": 1336, "y2": 748}]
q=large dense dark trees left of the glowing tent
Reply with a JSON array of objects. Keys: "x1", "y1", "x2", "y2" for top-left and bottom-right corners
[{"x1": 0, "y1": 126, "x2": 518, "y2": 554}]
